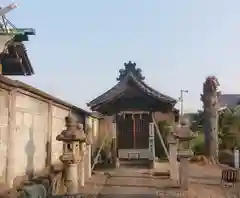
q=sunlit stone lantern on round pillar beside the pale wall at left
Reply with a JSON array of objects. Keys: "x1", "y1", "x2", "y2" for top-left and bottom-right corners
[{"x1": 56, "y1": 116, "x2": 86, "y2": 194}]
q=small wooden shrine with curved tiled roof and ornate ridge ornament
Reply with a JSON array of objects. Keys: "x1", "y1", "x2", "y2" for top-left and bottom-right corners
[{"x1": 88, "y1": 62, "x2": 178, "y2": 163}]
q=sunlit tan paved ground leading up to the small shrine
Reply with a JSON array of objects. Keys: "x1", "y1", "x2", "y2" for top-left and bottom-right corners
[{"x1": 82, "y1": 163, "x2": 238, "y2": 198}]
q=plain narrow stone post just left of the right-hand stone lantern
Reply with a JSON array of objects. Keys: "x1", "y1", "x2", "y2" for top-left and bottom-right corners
[{"x1": 168, "y1": 126, "x2": 179, "y2": 183}]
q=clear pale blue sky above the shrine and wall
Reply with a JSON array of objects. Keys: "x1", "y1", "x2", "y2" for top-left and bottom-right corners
[{"x1": 1, "y1": 0, "x2": 240, "y2": 111}]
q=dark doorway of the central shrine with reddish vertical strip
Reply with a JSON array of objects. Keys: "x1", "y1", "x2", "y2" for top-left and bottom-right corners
[{"x1": 117, "y1": 113, "x2": 150, "y2": 158}]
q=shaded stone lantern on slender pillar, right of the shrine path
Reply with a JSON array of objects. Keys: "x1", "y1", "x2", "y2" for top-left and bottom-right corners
[{"x1": 174, "y1": 118, "x2": 195, "y2": 190}]
